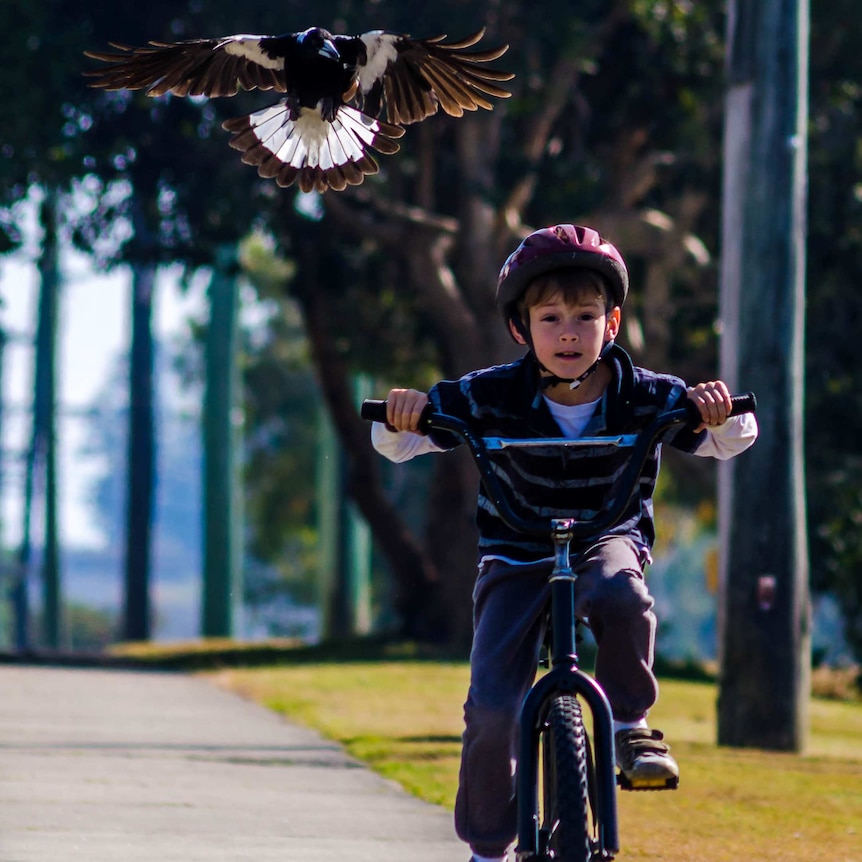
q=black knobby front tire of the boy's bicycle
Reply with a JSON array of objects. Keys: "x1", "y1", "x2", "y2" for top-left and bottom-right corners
[{"x1": 541, "y1": 694, "x2": 593, "y2": 862}]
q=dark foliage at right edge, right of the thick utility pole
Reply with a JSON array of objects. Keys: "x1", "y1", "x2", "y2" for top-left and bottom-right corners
[{"x1": 805, "y1": 0, "x2": 862, "y2": 661}]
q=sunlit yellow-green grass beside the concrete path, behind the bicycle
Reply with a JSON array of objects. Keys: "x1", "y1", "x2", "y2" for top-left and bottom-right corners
[{"x1": 209, "y1": 661, "x2": 862, "y2": 862}]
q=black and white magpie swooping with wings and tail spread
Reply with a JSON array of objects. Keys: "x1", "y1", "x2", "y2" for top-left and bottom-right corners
[{"x1": 84, "y1": 27, "x2": 514, "y2": 191}]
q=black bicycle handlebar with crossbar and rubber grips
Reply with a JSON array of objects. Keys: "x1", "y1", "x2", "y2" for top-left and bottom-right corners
[{"x1": 360, "y1": 392, "x2": 757, "y2": 539}]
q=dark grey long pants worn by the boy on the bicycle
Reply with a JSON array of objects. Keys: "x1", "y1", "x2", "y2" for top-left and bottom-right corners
[{"x1": 455, "y1": 536, "x2": 658, "y2": 856}]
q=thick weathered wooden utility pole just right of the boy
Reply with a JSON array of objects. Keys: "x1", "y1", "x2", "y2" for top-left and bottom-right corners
[{"x1": 718, "y1": 0, "x2": 810, "y2": 751}]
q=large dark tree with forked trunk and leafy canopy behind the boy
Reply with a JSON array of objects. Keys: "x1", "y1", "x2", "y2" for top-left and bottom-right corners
[{"x1": 67, "y1": 2, "x2": 740, "y2": 643}]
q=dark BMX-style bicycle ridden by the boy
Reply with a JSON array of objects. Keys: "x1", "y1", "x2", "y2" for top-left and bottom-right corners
[{"x1": 361, "y1": 392, "x2": 757, "y2": 862}]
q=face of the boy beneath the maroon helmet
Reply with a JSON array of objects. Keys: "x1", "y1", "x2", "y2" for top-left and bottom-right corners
[{"x1": 513, "y1": 290, "x2": 620, "y2": 379}]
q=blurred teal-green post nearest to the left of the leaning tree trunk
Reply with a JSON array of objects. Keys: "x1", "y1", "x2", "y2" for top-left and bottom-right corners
[{"x1": 201, "y1": 246, "x2": 242, "y2": 637}]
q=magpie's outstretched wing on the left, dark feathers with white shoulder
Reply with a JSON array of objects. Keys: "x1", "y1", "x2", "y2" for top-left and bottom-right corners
[{"x1": 84, "y1": 34, "x2": 294, "y2": 96}]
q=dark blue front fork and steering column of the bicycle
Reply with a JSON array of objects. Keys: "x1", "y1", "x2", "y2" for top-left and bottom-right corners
[{"x1": 516, "y1": 518, "x2": 619, "y2": 862}]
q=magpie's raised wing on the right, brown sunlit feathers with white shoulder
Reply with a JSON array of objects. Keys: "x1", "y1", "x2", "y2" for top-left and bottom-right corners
[{"x1": 334, "y1": 29, "x2": 515, "y2": 124}]
